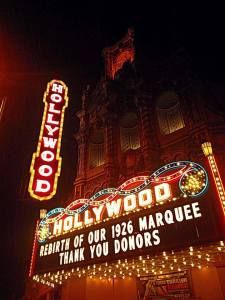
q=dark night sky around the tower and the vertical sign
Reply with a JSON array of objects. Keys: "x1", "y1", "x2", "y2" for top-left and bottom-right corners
[{"x1": 0, "y1": 0, "x2": 225, "y2": 299}]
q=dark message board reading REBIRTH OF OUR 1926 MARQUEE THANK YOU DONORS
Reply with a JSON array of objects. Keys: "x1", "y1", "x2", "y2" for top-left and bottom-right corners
[{"x1": 35, "y1": 196, "x2": 222, "y2": 273}]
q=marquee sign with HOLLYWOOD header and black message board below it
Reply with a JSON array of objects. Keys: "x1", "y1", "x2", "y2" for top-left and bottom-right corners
[{"x1": 33, "y1": 161, "x2": 224, "y2": 274}]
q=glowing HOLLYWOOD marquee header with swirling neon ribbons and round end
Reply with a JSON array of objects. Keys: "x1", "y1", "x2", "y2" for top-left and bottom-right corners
[{"x1": 38, "y1": 161, "x2": 208, "y2": 242}]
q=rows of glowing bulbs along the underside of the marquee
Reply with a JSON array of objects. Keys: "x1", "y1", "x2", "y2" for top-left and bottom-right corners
[{"x1": 33, "y1": 241, "x2": 225, "y2": 287}]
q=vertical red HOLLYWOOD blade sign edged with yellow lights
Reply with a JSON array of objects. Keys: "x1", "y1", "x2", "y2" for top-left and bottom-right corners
[{"x1": 29, "y1": 80, "x2": 68, "y2": 201}]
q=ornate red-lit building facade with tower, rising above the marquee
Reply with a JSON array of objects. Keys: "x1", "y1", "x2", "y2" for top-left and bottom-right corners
[{"x1": 74, "y1": 30, "x2": 225, "y2": 204}]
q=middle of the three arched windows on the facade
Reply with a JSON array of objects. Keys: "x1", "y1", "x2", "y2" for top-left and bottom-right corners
[{"x1": 120, "y1": 112, "x2": 140, "y2": 152}]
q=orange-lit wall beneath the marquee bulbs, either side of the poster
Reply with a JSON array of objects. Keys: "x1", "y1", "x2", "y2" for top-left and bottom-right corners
[{"x1": 61, "y1": 266, "x2": 225, "y2": 300}]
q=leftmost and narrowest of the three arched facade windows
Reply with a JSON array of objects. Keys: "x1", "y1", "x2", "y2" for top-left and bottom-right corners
[{"x1": 89, "y1": 128, "x2": 104, "y2": 168}]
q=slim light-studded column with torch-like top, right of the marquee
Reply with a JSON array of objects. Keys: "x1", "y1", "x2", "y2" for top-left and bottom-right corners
[{"x1": 202, "y1": 142, "x2": 225, "y2": 214}]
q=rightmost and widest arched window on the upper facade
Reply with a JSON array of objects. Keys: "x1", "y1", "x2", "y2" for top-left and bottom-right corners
[{"x1": 156, "y1": 91, "x2": 185, "y2": 135}]
